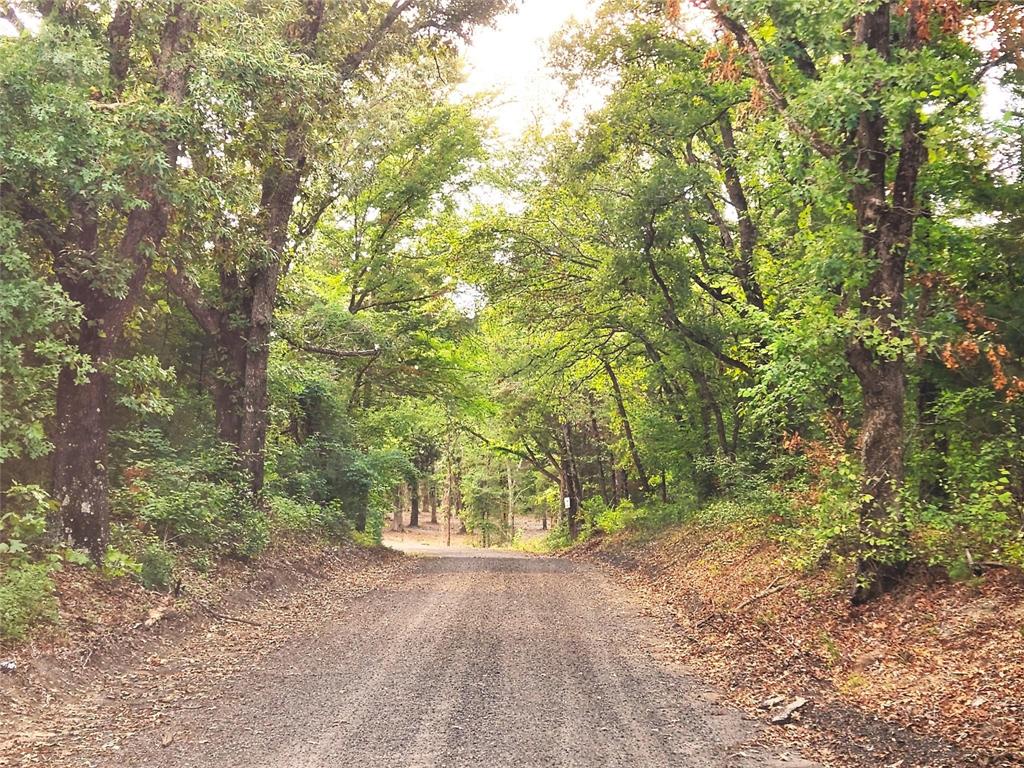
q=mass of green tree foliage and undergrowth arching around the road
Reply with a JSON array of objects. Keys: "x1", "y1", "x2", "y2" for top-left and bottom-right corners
[{"x1": 0, "y1": 0, "x2": 1024, "y2": 633}]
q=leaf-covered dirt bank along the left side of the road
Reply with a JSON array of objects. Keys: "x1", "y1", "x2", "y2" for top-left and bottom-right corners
[{"x1": 0, "y1": 541, "x2": 408, "y2": 766}]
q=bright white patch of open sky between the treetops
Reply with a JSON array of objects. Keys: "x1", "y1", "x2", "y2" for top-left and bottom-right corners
[{"x1": 460, "y1": 0, "x2": 599, "y2": 142}]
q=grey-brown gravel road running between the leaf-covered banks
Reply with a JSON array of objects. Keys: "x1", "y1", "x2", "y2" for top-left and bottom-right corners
[{"x1": 100, "y1": 547, "x2": 811, "y2": 768}]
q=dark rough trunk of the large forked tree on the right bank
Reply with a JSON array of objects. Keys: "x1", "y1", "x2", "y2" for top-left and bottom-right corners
[{"x1": 708, "y1": 0, "x2": 928, "y2": 603}]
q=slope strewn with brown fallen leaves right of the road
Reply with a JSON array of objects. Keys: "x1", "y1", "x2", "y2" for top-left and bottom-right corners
[{"x1": 568, "y1": 524, "x2": 1024, "y2": 768}]
